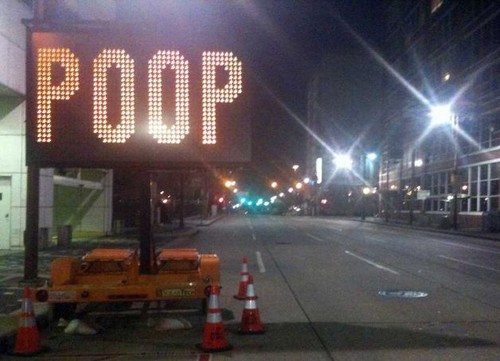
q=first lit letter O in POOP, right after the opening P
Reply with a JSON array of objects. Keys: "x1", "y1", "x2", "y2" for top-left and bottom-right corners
[{"x1": 94, "y1": 49, "x2": 135, "y2": 143}]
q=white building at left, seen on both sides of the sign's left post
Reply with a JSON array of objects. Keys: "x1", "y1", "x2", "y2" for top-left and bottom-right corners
[{"x1": 0, "y1": 0, "x2": 113, "y2": 249}]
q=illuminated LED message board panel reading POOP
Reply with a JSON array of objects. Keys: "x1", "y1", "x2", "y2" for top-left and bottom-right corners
[{"x1": 27, "y1": 31, "x2": 250, "y2": 167}]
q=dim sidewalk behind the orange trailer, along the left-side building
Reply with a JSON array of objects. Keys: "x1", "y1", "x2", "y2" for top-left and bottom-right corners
[{"x1": 0, "y1": 216, "x2": 222, "y2": 355}]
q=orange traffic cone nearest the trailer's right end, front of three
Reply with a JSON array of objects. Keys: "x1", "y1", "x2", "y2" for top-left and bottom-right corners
[{"x1": 197, "y1": 285, "x2": 233, "y2": 352}]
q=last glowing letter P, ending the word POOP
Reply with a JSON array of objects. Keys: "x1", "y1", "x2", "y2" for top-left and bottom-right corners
[{"x1": 202, "y1": 51, "x2": 242, "y2": 144}]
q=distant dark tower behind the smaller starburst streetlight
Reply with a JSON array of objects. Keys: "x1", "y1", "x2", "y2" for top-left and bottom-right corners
[{"x1": 306, "y1": 42, "x2": 383, "y2": 215}]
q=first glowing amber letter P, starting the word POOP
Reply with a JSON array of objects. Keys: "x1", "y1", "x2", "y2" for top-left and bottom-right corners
[{"x1": 37, "y1": 48, "x2": 79, "y2": 143}]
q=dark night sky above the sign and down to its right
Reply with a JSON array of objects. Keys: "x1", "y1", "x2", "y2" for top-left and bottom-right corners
[{"x1": 48, "y1": 0, "x2": 383, "y2": 191}]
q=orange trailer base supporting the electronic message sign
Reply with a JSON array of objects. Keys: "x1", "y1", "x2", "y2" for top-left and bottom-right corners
[{"x1": 35, "y1": 248, "x2": 220, "y2": 317}]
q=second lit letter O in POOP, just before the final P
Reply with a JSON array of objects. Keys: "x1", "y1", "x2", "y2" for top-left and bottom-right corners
[{"x1": 148, "y1": 50, "x2": 189, "y2": 144}]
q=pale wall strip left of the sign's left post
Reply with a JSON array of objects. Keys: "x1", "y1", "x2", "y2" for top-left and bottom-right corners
[{"x1": 0, "y1": 0, "x2": 32, "y2": 249}]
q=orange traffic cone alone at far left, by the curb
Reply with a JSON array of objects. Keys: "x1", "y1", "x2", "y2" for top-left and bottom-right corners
[{"x1": 14, "y1": 287, "x2": 42, "y2": 356}]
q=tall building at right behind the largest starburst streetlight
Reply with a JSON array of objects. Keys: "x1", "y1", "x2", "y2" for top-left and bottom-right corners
[{"x1": 379, "y1": 0, "x2": 500, "y2": 228}]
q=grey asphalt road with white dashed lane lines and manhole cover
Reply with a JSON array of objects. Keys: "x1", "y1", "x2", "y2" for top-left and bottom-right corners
[{"x1": 4, "y1": 216, "x2": 500, "y2": 361}]
